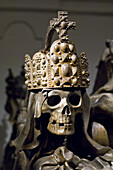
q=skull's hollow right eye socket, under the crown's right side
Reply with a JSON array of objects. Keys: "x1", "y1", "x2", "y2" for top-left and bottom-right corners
[{"x1": 68, "y1": 93, "x2": 81, "y2": 106}]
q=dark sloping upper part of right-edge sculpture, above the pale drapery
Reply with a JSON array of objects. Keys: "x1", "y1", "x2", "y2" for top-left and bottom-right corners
[{"x1": 93, "y1": 39, "x2": 113, "y2": 93}]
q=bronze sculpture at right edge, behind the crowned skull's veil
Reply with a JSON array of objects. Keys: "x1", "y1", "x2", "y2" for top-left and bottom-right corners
[{"x1": 89, "y1": 40, "x2": 113, "y2": 148}]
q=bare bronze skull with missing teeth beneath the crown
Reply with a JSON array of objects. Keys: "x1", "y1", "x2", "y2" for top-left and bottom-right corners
[{"x1": 42, "y1": 90, "x2": 82, "y2": 135}]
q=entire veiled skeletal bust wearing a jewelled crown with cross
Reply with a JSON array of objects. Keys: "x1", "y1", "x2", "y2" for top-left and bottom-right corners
[{"x1": 12, "y1": 11, "x2": 113, "y2": 170}]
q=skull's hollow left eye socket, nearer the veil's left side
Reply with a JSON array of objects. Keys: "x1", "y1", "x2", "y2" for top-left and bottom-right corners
[{"x1": 47, "y1": 95, "x2": 61, "y2": 106}]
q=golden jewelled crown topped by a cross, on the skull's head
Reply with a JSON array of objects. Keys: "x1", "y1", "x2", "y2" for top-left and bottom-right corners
[{"x1": 25, "y1": 11, "x2": 90, "y2": 90}]
